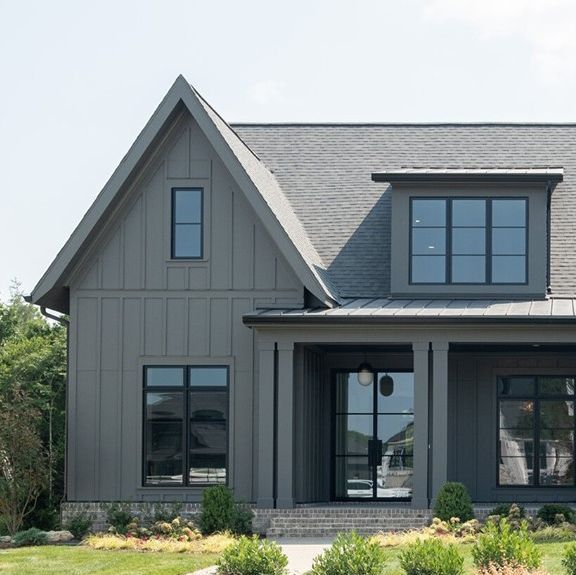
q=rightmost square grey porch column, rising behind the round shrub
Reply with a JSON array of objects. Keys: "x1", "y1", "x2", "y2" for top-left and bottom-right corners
[{"x1": 432, "y1": 341, "x2": 449, "y2": 499}]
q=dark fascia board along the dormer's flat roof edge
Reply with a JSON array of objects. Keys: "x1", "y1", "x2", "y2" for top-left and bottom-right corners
[{"x1": 372, "y1": 172, "x2": 564, "y2": 184}]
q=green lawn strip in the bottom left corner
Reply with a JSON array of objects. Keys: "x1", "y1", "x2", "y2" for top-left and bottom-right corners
[{"x1": 0, "y1": 545, "x2": 217, "y2": 575}]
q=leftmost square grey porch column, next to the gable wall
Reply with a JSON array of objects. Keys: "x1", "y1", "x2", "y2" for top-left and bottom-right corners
[{"x1": 256, "y1": 341, "x2": 274, "y2": 509}]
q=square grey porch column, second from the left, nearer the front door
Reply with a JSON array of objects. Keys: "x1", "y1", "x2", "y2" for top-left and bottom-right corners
[{"x1": 276, "y1": 342, "x2": 294, "y2": 509}]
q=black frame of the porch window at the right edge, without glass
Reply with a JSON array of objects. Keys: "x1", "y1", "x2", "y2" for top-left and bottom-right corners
[{"x1": 496, "y1": 373, "x2": 576, "y2": 490}]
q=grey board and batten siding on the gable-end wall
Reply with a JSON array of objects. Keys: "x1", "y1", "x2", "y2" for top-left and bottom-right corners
[{"x1": 67, "y1": 114, "x2": 304, "y2": 501}]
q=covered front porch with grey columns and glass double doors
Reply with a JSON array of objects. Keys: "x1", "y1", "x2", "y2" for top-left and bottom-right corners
[{"x1": 246, "y1": 306, "x2": 576, "y2": 509}]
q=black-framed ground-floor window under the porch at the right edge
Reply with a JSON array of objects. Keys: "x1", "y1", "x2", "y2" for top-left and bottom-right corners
[{"x1": 498, "y1": 375, "x2": 576, "y2": 487}]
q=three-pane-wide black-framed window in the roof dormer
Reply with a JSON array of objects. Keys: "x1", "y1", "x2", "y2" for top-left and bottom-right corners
[{"x1": 410, "y1": 197, "x2": 528, "y2": 285}]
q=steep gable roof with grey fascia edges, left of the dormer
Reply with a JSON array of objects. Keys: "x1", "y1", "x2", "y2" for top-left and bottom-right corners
[{"x1": 30, "y1": 76, "x2": 338, "y2": 312}]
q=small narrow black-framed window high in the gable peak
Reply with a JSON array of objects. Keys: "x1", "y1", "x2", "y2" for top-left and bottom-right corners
[{"x1": 172, "y1": 188, "x2": 204, "y2": 259}]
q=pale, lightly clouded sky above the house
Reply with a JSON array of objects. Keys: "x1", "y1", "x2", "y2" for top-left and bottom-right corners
[{"x1": 0, "y1": 0, "x2": 576, "y2": 298}]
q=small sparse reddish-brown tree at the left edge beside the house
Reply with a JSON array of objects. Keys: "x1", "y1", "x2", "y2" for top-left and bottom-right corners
[{"x1": 0, "y1": 389, "x2": 48, "y2": 534}]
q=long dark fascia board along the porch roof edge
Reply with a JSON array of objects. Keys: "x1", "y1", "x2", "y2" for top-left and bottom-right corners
[{"x1": 242, "y1": 314, "x2": 576, "y2": 327}]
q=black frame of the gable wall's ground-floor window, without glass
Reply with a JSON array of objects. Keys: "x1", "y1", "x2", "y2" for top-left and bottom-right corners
[{"x1": 142, "y1": 364, "x2": 230, "y2": 489}]
